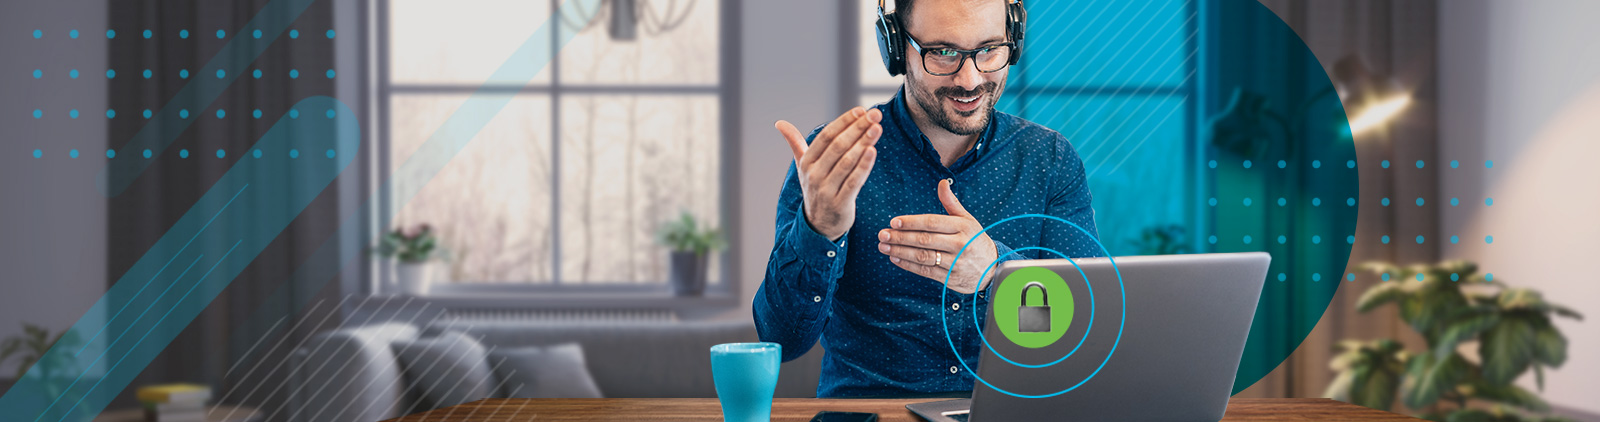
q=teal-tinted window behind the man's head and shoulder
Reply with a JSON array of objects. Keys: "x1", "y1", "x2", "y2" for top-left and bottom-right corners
[{"x1": 856, "y1": 0, "x2": 1203, "y2": 256}]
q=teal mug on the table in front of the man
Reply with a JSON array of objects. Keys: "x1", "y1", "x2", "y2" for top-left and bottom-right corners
[{"x1": 710, "y1": 342, "x2": 782, "y2": 422}]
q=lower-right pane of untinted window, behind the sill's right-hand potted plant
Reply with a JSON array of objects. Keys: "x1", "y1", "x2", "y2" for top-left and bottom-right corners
[{"x1": 560, "y1": 96, "x2": 722, "y2": 283}]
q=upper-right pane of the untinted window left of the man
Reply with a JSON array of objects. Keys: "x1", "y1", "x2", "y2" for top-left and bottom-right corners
[{"x1": 562, "y1": 0, "x2": 718, "y2": 85}]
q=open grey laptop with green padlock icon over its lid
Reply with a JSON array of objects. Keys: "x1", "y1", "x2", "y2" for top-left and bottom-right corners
[{"x1": 906, "y1": 253, "x2": 1272, "y2": 422}]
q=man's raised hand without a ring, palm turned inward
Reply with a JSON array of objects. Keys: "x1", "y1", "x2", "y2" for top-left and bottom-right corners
[{"x1": 773, "y1": 107, "x2": 883, "y2": 241}]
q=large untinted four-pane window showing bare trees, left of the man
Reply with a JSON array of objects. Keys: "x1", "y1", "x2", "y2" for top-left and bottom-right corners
[{"x1": 374, "y1": 0, "x2": 731, "y2": 288}]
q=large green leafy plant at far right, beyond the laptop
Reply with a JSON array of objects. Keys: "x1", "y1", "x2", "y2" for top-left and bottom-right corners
[{"x1": 1326, "y1": 261, "x2": 1582, "y2": 422}]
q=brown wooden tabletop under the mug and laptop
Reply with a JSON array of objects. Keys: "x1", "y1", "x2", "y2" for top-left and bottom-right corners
[{"x1": 380, "y1": 398, "x2": 1419, "y2": 422}]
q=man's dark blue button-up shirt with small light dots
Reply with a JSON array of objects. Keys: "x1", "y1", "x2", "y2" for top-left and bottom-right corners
[{"x1": 752, "y1": 90, "x2": 1101, "y2": 396}]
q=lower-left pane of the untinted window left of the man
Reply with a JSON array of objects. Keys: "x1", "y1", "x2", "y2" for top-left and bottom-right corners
[{"x1": 389, "y1": 94, "x2": 552, "y2": 283}]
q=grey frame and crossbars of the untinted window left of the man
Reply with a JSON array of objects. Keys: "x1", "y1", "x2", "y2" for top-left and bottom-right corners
[{"x1": 363, "y1": 0, "x2": 741, "y2": 303}]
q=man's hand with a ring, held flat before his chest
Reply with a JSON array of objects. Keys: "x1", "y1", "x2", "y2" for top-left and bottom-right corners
[{"x1": 878, "y1": 179, "x2": 997, "y2": 294}]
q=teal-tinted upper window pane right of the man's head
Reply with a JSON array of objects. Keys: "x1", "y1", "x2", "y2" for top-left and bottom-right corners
[{"x1": 1011, "y1": 0, "x2": 1197, "y2": 86}]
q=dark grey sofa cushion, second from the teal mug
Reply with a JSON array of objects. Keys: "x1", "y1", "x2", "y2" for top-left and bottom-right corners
[{"x1": 392, "y1": 331, "x2": 494, "y2": 408}]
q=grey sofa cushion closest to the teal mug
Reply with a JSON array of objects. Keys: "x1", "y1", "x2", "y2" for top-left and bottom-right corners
[{"x1": 490, "y1": 342, "x2": 600, "y2": 398}]
